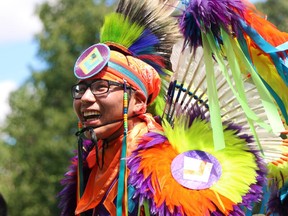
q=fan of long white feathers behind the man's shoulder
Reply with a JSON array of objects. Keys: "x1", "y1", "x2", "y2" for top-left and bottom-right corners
[{"x1": 169, "y1": 41, "x2": 288, "y2": 163}]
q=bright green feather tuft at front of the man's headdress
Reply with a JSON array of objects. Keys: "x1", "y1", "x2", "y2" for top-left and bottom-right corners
[{"x1": 100, "y1": 13, "x2": 144, "y2": 48}]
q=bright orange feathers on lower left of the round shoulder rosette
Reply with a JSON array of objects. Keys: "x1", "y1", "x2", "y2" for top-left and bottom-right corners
[{"x1": 138, "y1": 142, "x2": 235, "y2": 215}]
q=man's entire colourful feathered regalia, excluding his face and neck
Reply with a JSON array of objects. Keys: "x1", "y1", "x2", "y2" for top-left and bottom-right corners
[{"x1": 60, "y1": 0, "x2": 288, "y2": 216}]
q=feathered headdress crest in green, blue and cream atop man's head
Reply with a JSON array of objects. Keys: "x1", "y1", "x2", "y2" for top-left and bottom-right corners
[{"x1": 100, "y1": 0, "x2": 179, "y2": 74}]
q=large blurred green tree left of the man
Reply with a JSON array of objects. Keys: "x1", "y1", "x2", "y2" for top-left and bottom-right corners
[{"x1": 0, "y1": 0, "x2": 112, "y2": 216}]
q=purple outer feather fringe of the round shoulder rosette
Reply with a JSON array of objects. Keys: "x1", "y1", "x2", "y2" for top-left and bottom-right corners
[{"x1": 127, "y1": 105, "x2": 267, "y2": 216}]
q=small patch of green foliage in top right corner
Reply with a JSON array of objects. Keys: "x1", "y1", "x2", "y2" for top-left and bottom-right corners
[{"x1": 255, "y1": 0, "x2": 288, "y2": 32}]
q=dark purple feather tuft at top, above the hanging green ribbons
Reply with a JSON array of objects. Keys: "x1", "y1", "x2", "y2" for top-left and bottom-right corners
[{"x1": 179, "y1": 0, "x2": 245, "y2": 48}]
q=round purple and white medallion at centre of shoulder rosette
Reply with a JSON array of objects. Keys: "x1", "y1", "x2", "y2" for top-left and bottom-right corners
[{"x1": 171, "y1": 150, "x2": 222, "y2": 190}]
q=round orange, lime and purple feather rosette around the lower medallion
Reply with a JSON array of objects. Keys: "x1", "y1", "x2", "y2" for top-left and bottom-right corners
[{"x1": 127, "y1": 104, "x2": 266, "y2": 215}]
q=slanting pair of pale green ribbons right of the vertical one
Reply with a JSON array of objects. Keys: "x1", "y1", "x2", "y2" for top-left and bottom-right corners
[{"x1": 203, "y1": 29, "x2": 284, "y2": 152}]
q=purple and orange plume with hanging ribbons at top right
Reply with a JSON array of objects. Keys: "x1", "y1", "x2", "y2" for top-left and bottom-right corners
[{"x1": 173, "y1": 0, "x2": 288, "y2": 126}]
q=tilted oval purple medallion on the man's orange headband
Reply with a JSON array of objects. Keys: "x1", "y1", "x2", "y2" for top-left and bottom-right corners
[{"x1": 74, "y1": 44, "x2": 110, "y2": 79}]
